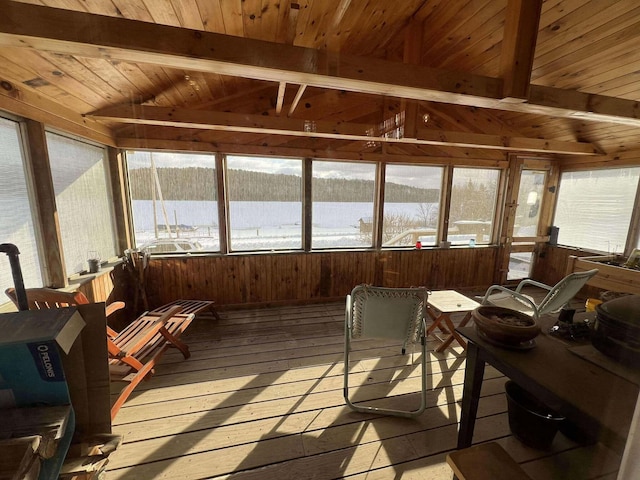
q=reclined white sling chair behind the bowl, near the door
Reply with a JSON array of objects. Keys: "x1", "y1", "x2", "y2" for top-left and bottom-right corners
[{"x1": 482, "y1": 268, "x2": 598, "y2": 319}]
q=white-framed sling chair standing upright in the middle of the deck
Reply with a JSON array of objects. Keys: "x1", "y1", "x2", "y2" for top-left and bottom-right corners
[{"x1": 344, "y1": 285, "x2": 428, "y2": 417}]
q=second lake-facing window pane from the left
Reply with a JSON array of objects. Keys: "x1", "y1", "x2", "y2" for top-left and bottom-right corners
[{"x1": 227, "y1": 155, "x2": 302, "y2": 251}]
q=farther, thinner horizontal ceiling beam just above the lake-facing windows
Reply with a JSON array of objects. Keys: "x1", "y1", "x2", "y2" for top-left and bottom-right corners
[{"x1": 89, "y1": 105, "x2": 600, "y2": 155}]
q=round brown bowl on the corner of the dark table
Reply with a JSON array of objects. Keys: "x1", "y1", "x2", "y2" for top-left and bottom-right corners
[{"x1": 471, "y1": 305, "x2": 540, "y2": 345}]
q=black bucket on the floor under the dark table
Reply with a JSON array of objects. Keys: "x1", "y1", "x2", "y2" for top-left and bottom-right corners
[{"x1": 504, "y1": 380, "x2": 564, "y2": 450}]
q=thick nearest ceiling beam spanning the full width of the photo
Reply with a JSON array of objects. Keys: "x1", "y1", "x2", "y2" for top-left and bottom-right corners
[{"x1": 0, "y1": 0, "x2": 640, "y2": 126}]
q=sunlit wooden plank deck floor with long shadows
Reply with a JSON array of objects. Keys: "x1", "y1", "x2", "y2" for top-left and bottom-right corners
[{"x1": 107, "y1": 303, "x2": 620, "y2": 480}]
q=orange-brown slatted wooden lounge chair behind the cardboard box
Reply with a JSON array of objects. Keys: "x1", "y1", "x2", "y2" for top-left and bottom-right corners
[{"x1": 6, "y1": 288, "x2": 194, "y2": 420}]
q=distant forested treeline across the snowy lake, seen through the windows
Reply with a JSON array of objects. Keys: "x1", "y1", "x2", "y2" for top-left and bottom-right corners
[{"x1": 129, "y1": 167, "x2": 440, "y2": 203}]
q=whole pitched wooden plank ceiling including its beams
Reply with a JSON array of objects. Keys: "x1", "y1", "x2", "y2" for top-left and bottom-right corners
[{"x1": 0, "y1": 0, "x2": 640, "y2": 162}]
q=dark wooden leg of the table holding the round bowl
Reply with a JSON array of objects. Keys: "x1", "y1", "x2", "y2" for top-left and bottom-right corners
[{"x1": 458, "y1": 343, "x2": 485, "y2": 449}]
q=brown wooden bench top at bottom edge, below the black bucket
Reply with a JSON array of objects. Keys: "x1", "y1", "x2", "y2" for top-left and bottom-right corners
[{"x1": 447, "y1": 442, "x2": 531, "y2": 480}]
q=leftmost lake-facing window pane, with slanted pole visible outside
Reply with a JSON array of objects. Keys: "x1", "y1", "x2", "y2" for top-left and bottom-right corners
[{"x1": 127, "y1": 151, "x2": 220, "y2": 253}]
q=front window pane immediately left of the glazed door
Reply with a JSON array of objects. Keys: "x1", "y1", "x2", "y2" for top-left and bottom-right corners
[{"x1": 447, "y1": 168, "x2": 500, "y2": 245}]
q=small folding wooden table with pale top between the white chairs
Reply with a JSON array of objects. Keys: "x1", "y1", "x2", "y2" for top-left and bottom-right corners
[{"x1": 427, "y1": 290, "x2": 480, "y2": 352}]
